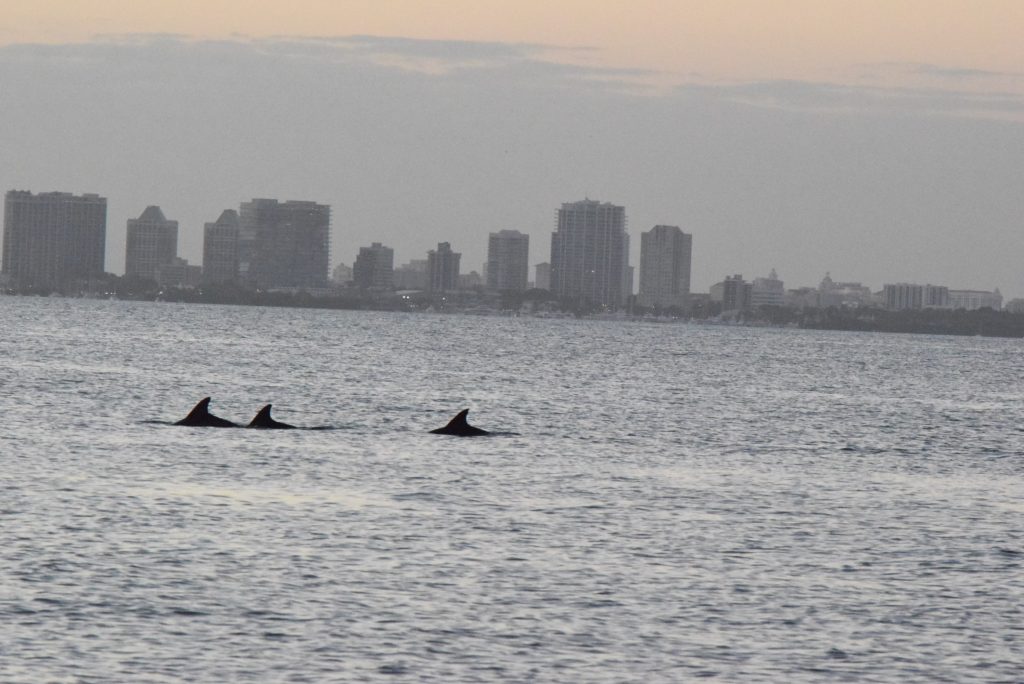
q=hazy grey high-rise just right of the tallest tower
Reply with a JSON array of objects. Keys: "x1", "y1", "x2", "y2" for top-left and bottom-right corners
[{"x1": 631, "y1": 225, "x2": 693, "y2": 308}]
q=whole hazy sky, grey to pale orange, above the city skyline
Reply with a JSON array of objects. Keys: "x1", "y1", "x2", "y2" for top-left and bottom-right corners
[{"x1": 0, "y1": 0, "x2": 1024, "y2": 298}]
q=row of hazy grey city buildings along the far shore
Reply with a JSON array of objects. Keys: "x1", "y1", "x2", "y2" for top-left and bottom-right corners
[{"x1": 0, "y1": 190, "x2": 1017, "y2": 308}]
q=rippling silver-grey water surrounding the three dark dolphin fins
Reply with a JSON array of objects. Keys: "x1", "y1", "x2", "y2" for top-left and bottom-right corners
[{"x1": 0, "y1": 297, "x2": 1024, "y2": 682}]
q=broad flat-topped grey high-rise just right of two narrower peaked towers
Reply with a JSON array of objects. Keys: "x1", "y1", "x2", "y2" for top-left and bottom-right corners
[{"x1": 239, "y1": 199, "x2": 331, "y2": 288}]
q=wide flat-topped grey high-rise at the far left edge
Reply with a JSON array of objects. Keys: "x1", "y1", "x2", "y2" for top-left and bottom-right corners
[{"x1": 2, "y1": 190, "x2": 106, "y2": 289}]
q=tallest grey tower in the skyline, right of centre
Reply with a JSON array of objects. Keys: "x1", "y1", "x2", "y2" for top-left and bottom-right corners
[{"x1": 551, "y1": 200, "x2": 630, "y2": 308}]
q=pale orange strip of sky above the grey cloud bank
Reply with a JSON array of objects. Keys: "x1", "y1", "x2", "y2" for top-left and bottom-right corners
[{"x1": 8, "y1": 0, "x2": 1024, "y2": 90}]
